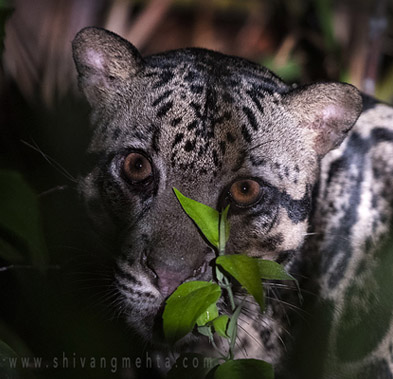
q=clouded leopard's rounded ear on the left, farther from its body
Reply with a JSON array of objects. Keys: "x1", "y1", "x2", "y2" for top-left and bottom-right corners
[{"x1": 72, "y1": 27, "x2": 143, "y2": 107}]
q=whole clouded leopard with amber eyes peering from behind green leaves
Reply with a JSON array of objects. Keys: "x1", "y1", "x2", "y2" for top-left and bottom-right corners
[{"x1": 73, "y1": 28, "x2": 393, "y2": 378}]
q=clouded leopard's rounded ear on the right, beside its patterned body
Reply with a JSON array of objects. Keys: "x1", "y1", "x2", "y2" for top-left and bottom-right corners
[{"x1": 284, "y1": 83, "x2": 363, "y2": 157}]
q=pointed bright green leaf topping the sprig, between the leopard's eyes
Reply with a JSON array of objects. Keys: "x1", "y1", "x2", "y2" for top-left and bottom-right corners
[{"x1": 173, "y1": 188, "x2": 220, "y2": 248}]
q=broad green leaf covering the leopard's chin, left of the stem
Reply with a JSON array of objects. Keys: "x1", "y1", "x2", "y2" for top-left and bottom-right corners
[{"x1": 162, "y1": 281, "x2": 221, "y2": 344}]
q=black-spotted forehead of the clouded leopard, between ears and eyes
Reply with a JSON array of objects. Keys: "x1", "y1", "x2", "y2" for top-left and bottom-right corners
[{"x1": 92, "y1": 49, "x2": 312, "y2": 196}]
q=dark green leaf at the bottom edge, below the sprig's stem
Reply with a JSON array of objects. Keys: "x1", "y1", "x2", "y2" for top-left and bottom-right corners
[{"x1": 214, "y1": 359, "x2": 274, "y2": 379}]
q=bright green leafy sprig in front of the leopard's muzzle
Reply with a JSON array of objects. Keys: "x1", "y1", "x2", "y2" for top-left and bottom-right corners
[{"x1": 163, "y1": 189, "x2": 294, "y2": 379}]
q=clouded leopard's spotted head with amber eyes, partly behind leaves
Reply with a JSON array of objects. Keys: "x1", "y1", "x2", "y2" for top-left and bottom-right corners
[{"x1": 73, "y1": 28, "x2": 362, "y2": 338}]
